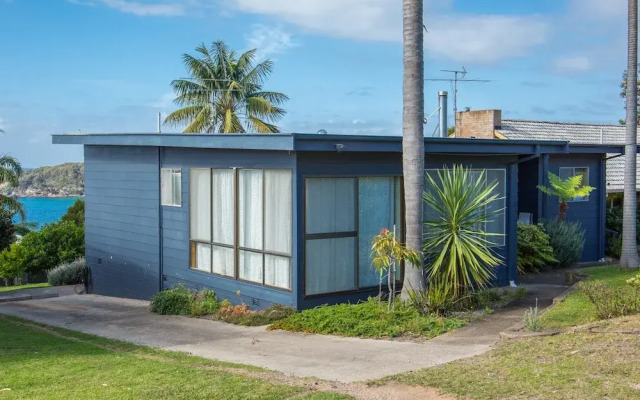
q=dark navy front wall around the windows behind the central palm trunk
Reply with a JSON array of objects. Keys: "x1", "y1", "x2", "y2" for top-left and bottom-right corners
[{"x1": 295, "y1": 152, "x2": 518, "y2": 308}]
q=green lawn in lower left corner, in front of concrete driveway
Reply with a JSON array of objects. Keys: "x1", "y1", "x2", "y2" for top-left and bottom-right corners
[{"x1": 0, "y1": 315, "x2": 351, "y2": 400}]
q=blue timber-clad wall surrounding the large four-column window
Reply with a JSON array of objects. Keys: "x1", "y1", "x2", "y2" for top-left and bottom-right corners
[{"x1": 161, "y1": 147, "x2": 297, "y2": 308}]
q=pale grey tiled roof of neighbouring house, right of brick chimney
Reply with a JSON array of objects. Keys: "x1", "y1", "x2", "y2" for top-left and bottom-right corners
[{"x1": 497, "y1": 119, "x2": 640, "y2": 192}]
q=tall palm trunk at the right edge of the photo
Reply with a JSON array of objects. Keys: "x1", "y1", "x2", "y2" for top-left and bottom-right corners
[{"x1": 620, "y1": 0, "x2": 640, "y2": 269}]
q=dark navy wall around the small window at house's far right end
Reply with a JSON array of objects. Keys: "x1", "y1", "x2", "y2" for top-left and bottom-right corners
[{"x1": 542, "y1": 154, "x2": 606, "y2": 262}]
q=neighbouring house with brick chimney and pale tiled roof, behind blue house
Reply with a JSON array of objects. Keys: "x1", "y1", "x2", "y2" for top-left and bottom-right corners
[{"x1": 456, "y1": 110, "x2": 640, "y2": 194}]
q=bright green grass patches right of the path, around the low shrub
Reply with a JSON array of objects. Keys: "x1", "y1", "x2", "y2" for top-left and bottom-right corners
[{"x1": 540, "y1": 266, "x2": 637, "y2": 329}]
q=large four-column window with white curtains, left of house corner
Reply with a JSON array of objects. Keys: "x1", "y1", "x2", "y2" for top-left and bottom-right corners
[{"x1": 190, "y1": 168, "x2": 293, "y2": 289}]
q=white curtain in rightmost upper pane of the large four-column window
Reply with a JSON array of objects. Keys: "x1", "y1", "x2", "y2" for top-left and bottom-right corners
[{"x1": 264, "y1": 170, "x2": 293, "y2": 254}]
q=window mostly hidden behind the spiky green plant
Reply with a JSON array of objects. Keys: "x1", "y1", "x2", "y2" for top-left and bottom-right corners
[{"x1": 423, "y1": 169, "x2": 507, "y2": 247}]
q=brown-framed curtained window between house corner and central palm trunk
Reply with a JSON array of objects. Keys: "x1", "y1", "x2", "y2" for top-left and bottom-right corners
[{"x1": 305, "y1": 177, "x2": 402, "y2": 296}]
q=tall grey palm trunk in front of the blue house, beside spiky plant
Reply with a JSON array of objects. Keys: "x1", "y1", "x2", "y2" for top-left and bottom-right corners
[{"x1": 402, "y1": 0, "x2": 424, "y2": 300}]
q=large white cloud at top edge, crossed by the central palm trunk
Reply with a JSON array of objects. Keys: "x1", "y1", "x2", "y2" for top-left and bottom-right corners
[{"x1": 229, "y1": 0, "x2": 550, "y2": 63}]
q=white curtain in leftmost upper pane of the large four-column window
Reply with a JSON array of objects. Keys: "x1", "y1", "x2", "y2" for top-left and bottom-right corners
[{"x1": 189, "y1": 168, "x2": 211, "y2": 242}]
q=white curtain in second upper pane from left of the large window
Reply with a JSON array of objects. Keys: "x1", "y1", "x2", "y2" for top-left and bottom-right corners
[{"x1": 211, "y1": 169, "x2": 235, "y2": 246}]
